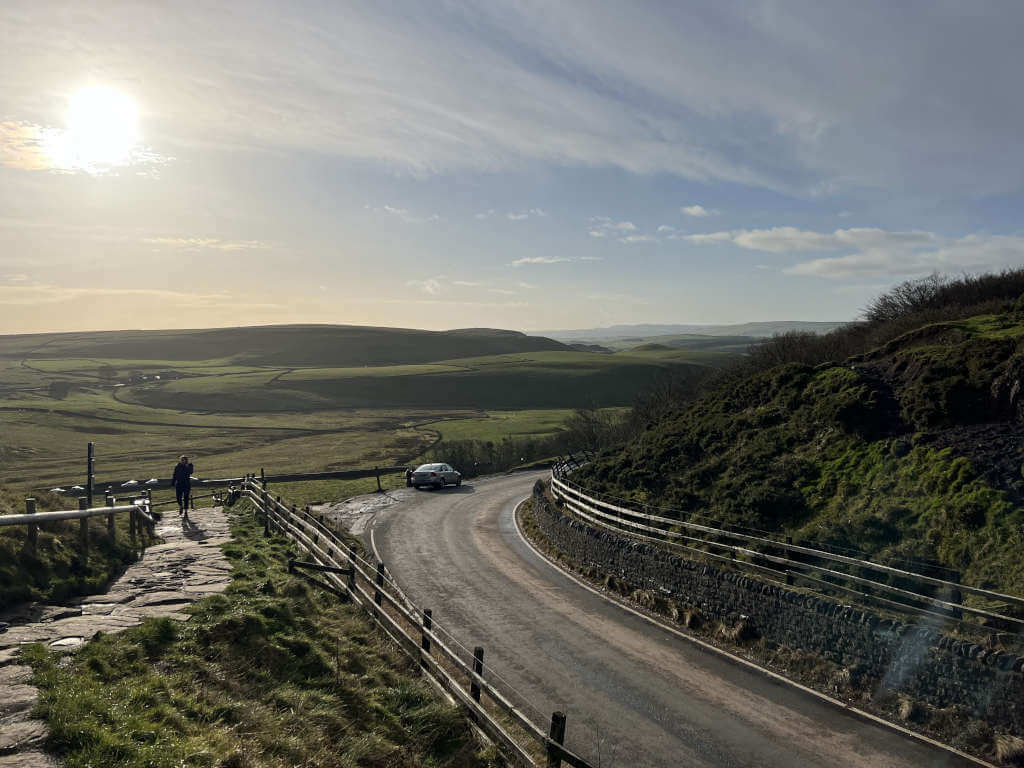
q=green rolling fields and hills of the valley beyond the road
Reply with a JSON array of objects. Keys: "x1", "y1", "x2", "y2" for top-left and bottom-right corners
[{"x1": 0, "y1": 326, "x2": 714, "y2": 488}]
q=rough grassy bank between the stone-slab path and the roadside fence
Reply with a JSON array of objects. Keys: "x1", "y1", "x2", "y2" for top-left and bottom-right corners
[{"x1": 25, "y1": 512, "x2": 494, "y2": 768}]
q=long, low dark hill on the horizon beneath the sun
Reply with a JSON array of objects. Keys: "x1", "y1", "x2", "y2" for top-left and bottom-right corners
[{"x1": 0, "y1": 326, "x2": 569, "y2": 367}]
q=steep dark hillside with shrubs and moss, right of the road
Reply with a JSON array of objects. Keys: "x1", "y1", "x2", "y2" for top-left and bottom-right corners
[{"x1": 580, "y1": 275, "x2": 1024, "y2": 594}]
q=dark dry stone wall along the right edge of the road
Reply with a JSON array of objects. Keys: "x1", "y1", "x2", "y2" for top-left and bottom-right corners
[{"x1": 534, "y1": 481, "x2": 1024, "y2": 735}]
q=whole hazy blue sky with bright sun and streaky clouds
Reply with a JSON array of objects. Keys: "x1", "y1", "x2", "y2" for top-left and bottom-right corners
[{"x1": 0, "y1": 0, "x2": 1024, "y2": 333}]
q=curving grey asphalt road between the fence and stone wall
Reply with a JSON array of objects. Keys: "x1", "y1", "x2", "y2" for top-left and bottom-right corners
[{"x1": 360, "y1": 473, "x2": 972, "y2": 768}]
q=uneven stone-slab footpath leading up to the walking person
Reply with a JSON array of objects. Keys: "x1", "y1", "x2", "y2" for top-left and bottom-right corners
[{"x1": 0, "y1": 507, "x2": 230, "y2": 768}]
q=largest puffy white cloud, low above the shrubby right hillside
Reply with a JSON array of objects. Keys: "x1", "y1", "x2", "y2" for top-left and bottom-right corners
[{"x1": 685, "y1": 226, "x2": 1024, "y2": 279}]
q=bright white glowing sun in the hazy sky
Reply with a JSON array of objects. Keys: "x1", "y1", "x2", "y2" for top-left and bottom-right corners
[{"x1": 50, "y1": 85, "x2": 139, "y2": 172}]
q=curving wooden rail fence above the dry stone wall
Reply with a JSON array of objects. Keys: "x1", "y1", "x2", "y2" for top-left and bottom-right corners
[{"x1": 551, "y1": 461, "x2": 1024, "y2": 632}]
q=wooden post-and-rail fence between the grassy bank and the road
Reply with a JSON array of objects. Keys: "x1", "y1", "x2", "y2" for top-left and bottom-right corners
[{"x1": 240, "y1": 475, "x2": 592, "y2": 768}]
